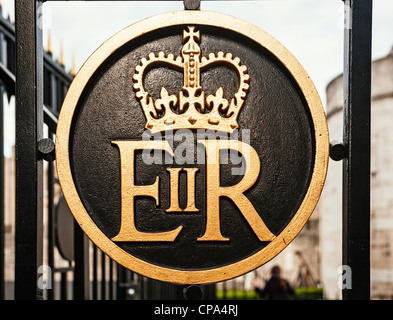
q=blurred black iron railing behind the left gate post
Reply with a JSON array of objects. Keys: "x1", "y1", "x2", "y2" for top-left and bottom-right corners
[{"x1": 0, "y1": 5, "x2": 214, "y2": 300}]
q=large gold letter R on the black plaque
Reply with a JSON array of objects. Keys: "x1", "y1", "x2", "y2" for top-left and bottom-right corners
[{"x1": 198, "y1": 140, "x2": 275, "y2": 241}]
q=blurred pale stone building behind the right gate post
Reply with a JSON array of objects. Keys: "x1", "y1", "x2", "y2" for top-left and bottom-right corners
[{"x1": 317, "y1": 46, "x2": 393, "y2": 299}]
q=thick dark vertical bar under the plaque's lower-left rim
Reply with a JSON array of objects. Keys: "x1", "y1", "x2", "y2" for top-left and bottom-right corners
[{"x1": 74, "y1": 221, "x2": 90, "y2": 300}]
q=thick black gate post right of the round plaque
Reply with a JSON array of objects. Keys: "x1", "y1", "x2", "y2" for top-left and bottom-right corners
[{"x1": 342, "y1": 0, "x2": 372, "y2": 300}]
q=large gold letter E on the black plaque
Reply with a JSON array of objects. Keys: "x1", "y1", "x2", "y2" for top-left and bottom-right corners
[{"x1": 112, "y1": 140, "x2": 183, "y2": 241}]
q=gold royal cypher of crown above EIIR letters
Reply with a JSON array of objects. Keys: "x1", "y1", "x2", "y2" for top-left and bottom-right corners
[{"x1": 112, "y1": 26, "x2": 275, "y2": 242}]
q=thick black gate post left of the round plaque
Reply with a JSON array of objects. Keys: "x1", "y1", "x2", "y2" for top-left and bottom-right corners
[{"x1": 15, "y1": 0, "x2": 43, "y2": 300}]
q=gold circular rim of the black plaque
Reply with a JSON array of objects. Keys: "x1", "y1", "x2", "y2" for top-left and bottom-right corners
[{"x1": 56, "y1": 11, "x2": 329, "y2": 284}]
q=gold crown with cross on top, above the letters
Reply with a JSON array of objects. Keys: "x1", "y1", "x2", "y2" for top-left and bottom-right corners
[{"x1": 133, "y1": 26, "x2": 249, "y2": 133}]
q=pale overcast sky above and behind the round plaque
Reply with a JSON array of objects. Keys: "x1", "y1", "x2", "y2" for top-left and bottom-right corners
[{"x1": 2, "y1": 0, "x2": 393, "y2": 155}]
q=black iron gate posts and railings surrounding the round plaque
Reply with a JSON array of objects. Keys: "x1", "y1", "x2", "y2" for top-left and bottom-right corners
[{"x1": 0, "y1": 0, "x2": 372, "y2": 299}]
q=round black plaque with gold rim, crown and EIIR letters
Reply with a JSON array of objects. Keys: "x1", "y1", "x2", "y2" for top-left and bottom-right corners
[{"x1": 56, "y1": 12, "x2": 329, "y2": 284}]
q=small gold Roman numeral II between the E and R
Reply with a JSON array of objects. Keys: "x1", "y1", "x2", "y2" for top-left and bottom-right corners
[{"x1": 165, "y1": 168, "x2": 199, "y2": 212}]
